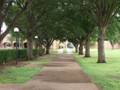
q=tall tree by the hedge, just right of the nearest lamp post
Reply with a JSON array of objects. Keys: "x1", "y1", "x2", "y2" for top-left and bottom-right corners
[{"x1": 17, "y1": 1, "x2": 56, "y2": 60}]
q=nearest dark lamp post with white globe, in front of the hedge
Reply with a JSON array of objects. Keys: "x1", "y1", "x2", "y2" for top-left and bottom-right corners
[{"x1": 14, "y1": 28, "x2": 19, "y2": 65}]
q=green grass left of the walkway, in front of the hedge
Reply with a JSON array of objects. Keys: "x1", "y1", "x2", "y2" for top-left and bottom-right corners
[{"x1": 0, "y1": 58, "x2": 51, "y2": 83}]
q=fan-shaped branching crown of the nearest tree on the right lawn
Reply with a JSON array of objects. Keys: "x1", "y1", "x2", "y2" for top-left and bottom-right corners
[{"x1": 87, "y1": 0, "x2": 120, "y2": 27}]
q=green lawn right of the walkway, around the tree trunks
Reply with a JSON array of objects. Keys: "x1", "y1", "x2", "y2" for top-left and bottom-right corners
[{"x1": 74, "y1": 49, "x2": 120, "y2": 90}]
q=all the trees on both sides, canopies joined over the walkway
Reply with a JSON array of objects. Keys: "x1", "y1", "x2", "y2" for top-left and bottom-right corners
[{"x1": 0, "y1": 0, "x2": 120, "y2": 63}]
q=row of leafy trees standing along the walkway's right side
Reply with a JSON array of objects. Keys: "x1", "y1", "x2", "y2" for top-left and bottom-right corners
[{"x1": 57, "y1": 0, "x2": 120, "y2": 63}]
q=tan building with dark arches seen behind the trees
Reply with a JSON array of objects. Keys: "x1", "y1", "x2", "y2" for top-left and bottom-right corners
[{"x1": 0, "y1": 34, "x2": 120, "y2": 50}]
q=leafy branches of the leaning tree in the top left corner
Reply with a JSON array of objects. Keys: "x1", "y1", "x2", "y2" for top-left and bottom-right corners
[{"x1": 0, "y1": 0, "x2": 31, "y2": 42}]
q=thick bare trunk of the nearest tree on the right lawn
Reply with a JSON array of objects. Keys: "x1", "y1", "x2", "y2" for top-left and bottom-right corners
[{"x1": 98, "y1": 27, "x2": 106, "y2": 63}]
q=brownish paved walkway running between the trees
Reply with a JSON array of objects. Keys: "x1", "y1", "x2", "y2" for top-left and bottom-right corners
[{"x1": 0, "y1": 55, "x2": 98, "y2": 90}]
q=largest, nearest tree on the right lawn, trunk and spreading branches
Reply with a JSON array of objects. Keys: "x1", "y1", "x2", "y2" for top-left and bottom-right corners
[{"x1": 86, "y1": 0, "x2": 120, "y2": 63}]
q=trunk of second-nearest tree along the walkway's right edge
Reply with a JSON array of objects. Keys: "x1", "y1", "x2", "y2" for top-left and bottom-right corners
[{"x1": 85, "y1": 33, "x2": 90, "y2": 57}]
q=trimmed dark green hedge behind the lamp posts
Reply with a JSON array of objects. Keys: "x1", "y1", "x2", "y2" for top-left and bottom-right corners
[{"x1": 0, "y1": 49, "x2": 40, "y2": 63}]
